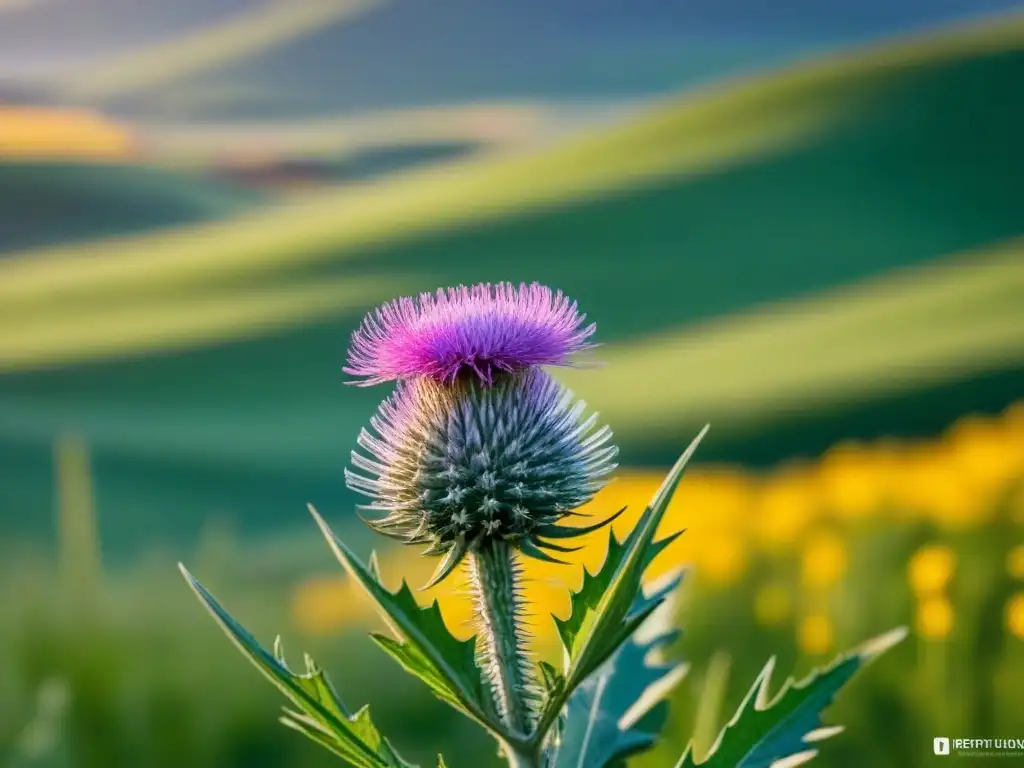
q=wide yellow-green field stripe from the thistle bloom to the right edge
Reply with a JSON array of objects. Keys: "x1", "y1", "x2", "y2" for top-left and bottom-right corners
[{"x1": 559, "y1": 240, "x2": 1024, "y2": 438}]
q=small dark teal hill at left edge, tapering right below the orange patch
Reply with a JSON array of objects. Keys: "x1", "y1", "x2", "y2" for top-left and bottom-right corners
[{"x1": 0, "y1": 161, "x2": 268, "y2": 258}]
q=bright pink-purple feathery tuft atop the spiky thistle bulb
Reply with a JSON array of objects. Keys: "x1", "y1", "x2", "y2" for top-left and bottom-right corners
[{"x1": 343, "y1": 283, "x2": 595, "y2": 386}]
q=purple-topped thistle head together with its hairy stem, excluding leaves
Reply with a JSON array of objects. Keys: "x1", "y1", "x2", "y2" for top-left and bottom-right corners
[{"x1": 345, "y1": 284, "x2": 617, "y2": 732}]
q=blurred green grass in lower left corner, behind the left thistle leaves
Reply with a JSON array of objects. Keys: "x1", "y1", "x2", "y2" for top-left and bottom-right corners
[{"x1": 0, "y1": 553, "x2": 487, "y2": 768}]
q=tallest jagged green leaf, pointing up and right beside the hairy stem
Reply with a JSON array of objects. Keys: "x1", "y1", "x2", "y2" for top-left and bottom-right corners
[{"x1": 539, "y1": 434, "x2": 709, "y2": 735}]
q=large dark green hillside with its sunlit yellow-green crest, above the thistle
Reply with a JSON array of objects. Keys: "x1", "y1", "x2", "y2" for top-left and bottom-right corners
[{"x1": 0, "y1": 17, "x2": 1024, "y2": 352}]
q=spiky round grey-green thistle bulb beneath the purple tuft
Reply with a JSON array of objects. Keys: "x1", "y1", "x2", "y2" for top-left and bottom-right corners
[{"x1": 345, "y1": 368, "x2": 617, "y2": 584}]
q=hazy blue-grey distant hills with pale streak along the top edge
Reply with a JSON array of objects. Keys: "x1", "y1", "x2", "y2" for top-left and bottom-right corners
[{"x1": 0, "y1": 0, "x2": 1019, "y2": 119}]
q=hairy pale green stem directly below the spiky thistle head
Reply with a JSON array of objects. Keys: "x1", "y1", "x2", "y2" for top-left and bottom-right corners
[{"x1": 468, "y1": 542, "x2": 535, "y2": 733}]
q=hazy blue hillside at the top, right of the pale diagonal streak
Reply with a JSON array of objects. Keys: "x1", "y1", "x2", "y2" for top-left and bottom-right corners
[{"x1": 101, "y1": 0, "x2": 1014, "y2": 119}]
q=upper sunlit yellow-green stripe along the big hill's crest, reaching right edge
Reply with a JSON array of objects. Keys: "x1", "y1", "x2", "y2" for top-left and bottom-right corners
[{"x1": 12, "y1": 14, "x2": 1024, "y2": 310}]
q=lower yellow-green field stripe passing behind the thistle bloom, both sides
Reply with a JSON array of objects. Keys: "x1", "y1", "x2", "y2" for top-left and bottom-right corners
[{"x1": 0, "y1": 227, "x2": 1024, "y2": 428}]
